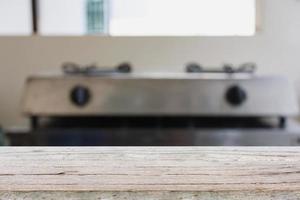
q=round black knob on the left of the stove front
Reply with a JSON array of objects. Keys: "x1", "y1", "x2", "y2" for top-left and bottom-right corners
[{"x1": 70, "y1": 86, "x2": 91, "y2": 107}]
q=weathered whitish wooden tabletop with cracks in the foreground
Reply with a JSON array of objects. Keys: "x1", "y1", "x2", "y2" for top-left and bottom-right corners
[{"x1": 0, "y1": 147, "x2": 300, "y2": 199}]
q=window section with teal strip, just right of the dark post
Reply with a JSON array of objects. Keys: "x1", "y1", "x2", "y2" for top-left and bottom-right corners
[{"x1": 39, "y1": 0, "x2": 109, "y2": 35}]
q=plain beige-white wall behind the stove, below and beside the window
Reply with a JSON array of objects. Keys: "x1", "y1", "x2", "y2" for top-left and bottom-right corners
[{"x1": 0, "y1": 0, "x2": 300, "y2": 127}]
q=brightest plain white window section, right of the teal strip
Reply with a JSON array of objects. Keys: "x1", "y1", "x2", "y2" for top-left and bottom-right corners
[{"x1": 109, "y1": 0, "x2": 256, "y2": 36}]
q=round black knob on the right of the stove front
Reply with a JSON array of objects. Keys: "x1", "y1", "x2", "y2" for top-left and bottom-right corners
[{"x1": 226, "y1": 85, "x2": 247, "y2": 106}]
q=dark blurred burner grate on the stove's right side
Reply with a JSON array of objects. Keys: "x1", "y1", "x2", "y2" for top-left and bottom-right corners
[{"x1": 186, "y1": 63, "x2": 256, "y2": 74}]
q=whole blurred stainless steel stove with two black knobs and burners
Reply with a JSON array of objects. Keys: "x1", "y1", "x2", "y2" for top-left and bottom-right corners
[{"x1": 16, "y1": 64, "x2": 300, "y2": 146}]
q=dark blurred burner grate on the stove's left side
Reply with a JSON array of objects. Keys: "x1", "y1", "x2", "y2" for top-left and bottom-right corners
[{"x1": 62, "y1": 62, "x2": 132, "y2": 76}]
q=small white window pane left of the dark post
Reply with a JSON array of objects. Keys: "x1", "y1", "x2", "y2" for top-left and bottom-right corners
[{"x1": 0, "y1": 0, "x2": 32, "y2": 35}]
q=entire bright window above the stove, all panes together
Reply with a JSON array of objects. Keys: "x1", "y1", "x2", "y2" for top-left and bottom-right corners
[{"x1": 0, "y1": 0, "x2": 256, "y2": 36}]
